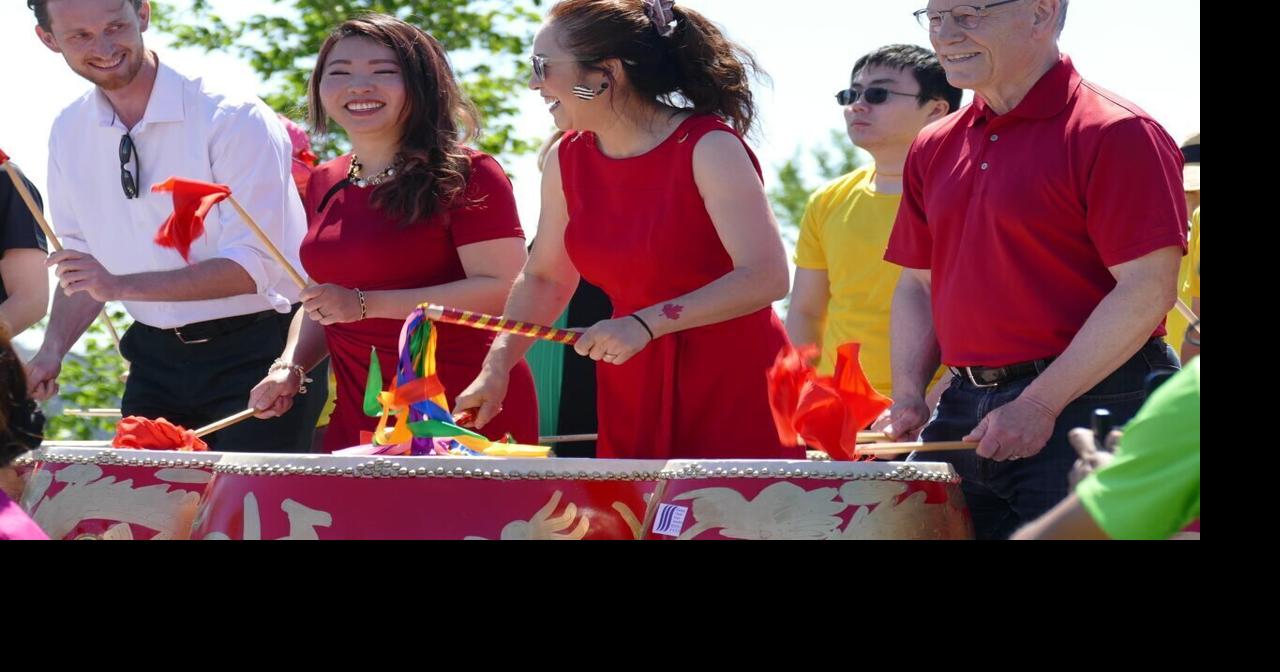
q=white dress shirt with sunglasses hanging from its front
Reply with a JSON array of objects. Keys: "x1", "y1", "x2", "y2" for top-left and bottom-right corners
[{"x1": 49, "y1": 56, "x2": 307, "y2": 329}]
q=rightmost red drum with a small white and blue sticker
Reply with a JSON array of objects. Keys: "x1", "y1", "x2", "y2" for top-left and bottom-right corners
[{"x1": 645, "y1": 460, "x2": 973, "y2": 539}]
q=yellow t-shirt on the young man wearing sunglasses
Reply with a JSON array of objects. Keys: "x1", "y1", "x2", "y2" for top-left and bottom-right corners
[{"x1": 795, "y1": 165, "x2": 936, "y2": 396}]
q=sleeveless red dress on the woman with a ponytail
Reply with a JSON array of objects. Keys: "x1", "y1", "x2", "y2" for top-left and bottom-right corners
[{"x1": 559, "y1": 115, "x2": 804, "y2": 460}]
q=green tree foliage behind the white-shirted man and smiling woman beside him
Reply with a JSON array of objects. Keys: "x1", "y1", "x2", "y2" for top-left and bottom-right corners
[{"x1": 38, "y1": 0, "x2": 543, "y2": 430}]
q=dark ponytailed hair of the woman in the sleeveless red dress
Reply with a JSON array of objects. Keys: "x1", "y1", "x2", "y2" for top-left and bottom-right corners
[{"x1": 549, "y1": 0, "x2": 764, "y2": 134}]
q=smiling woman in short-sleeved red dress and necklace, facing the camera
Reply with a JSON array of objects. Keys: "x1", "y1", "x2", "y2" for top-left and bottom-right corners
[{"x1": 251, "y1": 14, "x2": 538, "y2": 452}]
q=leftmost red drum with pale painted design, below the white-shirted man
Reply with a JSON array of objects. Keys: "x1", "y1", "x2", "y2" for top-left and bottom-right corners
[{"x1": 17, "y1": 443, "x2": 219, "y2": 539}]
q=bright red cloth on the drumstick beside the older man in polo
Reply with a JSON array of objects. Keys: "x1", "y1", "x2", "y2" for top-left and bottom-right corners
[{"x1": 768, "y1": 343, "x2": 893, "y2": 461}]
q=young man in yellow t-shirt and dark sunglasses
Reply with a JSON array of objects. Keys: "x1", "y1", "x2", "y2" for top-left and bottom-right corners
[{"x1": 787, "y1": 45, "x2": 960, "y2": 404}]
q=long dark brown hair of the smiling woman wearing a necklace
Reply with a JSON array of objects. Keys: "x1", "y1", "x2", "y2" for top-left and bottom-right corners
[{"x1": 308, "y1": 14, "x2": 480, "y2": 224}]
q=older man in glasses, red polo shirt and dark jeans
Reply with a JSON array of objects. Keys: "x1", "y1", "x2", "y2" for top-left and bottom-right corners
[{"x1": 884, "y1": 0, "x2": 1187, "y2": 539}]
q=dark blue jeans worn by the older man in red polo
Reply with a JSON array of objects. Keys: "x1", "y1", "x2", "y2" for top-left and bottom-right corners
[{"x1": 908, "y1": 340, "x2": 1179, "y2": 539}]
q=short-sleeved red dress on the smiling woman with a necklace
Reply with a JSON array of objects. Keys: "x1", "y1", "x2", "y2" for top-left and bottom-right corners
[{"x1": 301, "y1": 151, "x2": 538, "y2": 452}]
